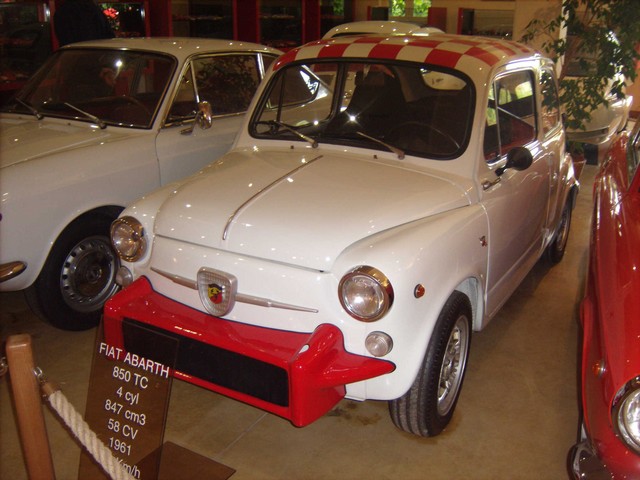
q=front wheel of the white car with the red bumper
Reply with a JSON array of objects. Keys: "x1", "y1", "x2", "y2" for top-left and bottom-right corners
[{"x1": 389, "y1": 292, "x2": 471, "y2": 437}]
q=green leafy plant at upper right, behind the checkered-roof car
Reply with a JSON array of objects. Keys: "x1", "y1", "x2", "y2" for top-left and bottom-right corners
[{"x1": 522, "y1": 0, "x2": 640, "y2": 133}]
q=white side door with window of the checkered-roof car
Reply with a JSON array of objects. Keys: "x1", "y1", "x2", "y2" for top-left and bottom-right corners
[{"x1": 480, "y1": 65, "x2": 549, "y2": 316}]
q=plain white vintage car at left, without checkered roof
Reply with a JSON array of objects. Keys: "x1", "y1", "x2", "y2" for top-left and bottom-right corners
[{"x1": 0, "y1": 38, "x2": 281, "y2": 330}]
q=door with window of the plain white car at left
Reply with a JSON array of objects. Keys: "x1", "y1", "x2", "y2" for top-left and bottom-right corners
[{"x1": 156, "y1": 52, "x2": 275, "y2": 185}]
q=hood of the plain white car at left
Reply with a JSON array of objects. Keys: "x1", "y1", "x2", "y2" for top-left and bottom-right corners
[{"x1": 0, "y1": 114, "x2": 131, "y2": 167}]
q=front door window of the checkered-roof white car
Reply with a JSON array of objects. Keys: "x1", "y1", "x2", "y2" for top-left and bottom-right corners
[{"x1": 484, "y1": 71, "x2": 536, "y2": 161}]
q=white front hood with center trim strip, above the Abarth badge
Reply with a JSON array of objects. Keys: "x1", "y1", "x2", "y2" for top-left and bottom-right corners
[{"x1": 155, "y1": 148, "x2": 469, "y2": 270}]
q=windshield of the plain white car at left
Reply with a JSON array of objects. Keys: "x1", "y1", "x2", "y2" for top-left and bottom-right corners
[{"x1": 3, "y1": 48, "x2": 176, "y2": 128}]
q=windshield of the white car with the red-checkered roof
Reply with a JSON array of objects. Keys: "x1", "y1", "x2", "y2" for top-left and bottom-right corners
[{"x1": 250, "y1": 60, "x2": 474, "y2": 159}]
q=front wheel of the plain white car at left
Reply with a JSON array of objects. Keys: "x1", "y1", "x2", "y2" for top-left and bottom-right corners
[{"x1": 25, "y1": 216, "x2": 120, "y2": 331}]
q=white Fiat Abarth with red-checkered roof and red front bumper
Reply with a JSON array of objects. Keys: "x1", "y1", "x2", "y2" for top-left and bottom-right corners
[{"x1": 104, "y1": 34, "x2": 578, "y2": 436}]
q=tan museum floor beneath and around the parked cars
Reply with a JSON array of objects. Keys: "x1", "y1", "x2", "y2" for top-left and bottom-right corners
[{"x1": 0, "y1": 165, "x2": 597, "y2": 480}]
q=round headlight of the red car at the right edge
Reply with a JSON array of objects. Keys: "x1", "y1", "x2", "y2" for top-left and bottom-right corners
[{"x1": 612, "y1": 377, "x2": 640, "y2": 454}]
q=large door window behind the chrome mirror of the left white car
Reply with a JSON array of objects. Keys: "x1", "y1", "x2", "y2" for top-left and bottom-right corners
[{"x1": 193, "y1": 54, "x2": 260, "y2": 115}]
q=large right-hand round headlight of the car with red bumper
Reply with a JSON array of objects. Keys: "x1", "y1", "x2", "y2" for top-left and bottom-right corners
[{"x1": 338, "y1": 266, "x2": 393, "y2": 322}]
